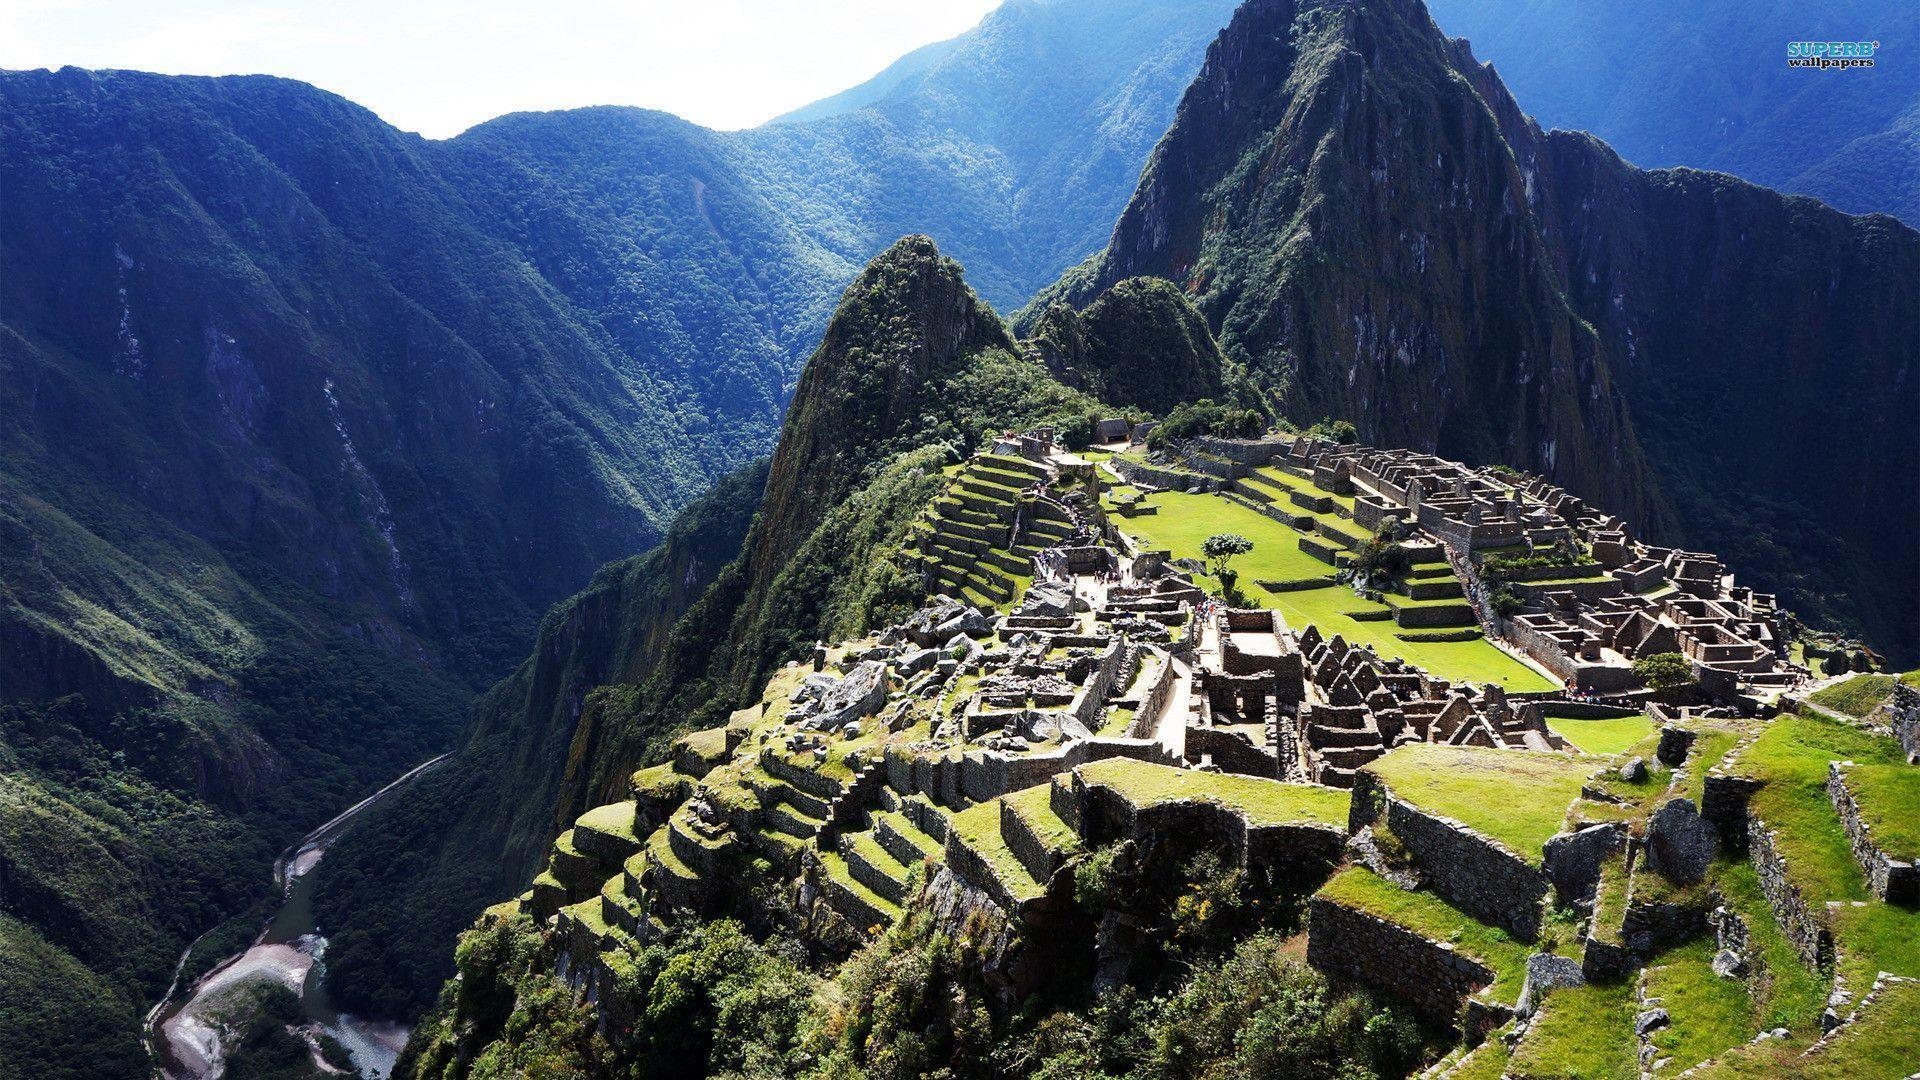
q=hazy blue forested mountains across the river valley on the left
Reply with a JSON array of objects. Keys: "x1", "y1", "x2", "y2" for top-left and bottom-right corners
[{"x1": 0, "y1": 0, "x2": 1231, "y2": 1076}]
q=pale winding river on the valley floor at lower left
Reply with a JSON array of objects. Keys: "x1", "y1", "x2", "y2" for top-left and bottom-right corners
[{"x1": 146, "y1": 755, "x2": 447, "y2": 1080}]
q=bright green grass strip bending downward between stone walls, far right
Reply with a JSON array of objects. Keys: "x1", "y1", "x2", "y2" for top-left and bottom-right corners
[{"x1": 1734, "y1": 715, "x2": 1901, "y2": 901}]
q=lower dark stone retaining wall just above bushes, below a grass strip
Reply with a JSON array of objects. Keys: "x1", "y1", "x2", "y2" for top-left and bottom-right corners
[{"x1": 1308, "y1": 897, "x2": 1494, "y2": 1024}]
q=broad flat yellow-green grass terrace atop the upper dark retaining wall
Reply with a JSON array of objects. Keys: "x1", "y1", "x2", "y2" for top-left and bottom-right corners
[{"x1": 1367, "y1": 744, "x2": 1594, "y2": 867}]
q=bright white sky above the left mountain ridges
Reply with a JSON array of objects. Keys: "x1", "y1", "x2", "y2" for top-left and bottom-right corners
[{"x1": 0, "y1": 0, "x2": 1000, "y2": 138}]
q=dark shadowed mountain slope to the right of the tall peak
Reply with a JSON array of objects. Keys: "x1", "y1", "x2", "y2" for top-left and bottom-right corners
[{"x1": 1542, "y1": 133, "x2": 1920, "y2": 653}]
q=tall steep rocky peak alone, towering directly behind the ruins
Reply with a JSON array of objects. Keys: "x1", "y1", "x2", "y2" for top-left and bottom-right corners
[{"x1": 1096, "y1": 0, "x2": 1647, "y2": 511}]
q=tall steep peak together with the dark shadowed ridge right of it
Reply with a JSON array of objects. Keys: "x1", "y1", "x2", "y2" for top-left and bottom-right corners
[{"x1": 1044, "y1": 0, "x2": 1920, "y2": 655}]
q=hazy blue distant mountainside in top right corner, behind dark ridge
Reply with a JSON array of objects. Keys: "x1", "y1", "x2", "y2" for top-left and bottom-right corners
[{"x1": 1428, "y1": 0, "x2": 1920, "y2": 225}]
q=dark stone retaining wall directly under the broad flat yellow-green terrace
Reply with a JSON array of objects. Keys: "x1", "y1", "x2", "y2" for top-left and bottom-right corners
[{"x1": 1348, "y1": 769, "x2": 1548, "y2": 942}]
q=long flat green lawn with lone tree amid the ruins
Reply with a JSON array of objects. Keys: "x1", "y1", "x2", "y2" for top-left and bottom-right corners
[{"x1": 1114, "y1": 492, "x2": 1557, "y2": 694}]
